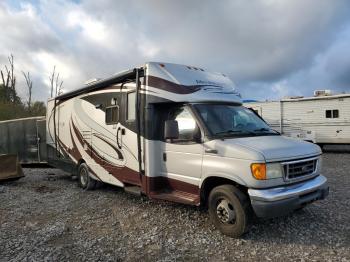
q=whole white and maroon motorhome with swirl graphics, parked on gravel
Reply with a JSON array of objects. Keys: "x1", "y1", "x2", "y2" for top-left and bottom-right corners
[{"x1": 47, "y1": 62, "x2": 328, "y2": 237}]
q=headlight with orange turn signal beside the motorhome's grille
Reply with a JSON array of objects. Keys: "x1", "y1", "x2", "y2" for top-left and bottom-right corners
[{"x1": 251, "y1": 163, "x2": 283, "y2": 180}]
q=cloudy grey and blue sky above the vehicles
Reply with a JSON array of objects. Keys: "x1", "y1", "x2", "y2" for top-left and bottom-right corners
[{"x1": 0, "y1": 0, "x2": 350, "y2": 101}]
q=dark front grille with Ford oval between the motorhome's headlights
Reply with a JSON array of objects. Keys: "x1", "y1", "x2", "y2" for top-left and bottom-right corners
[{"x1": 283, "y1": 159, "x2": 317, "y2": 180}]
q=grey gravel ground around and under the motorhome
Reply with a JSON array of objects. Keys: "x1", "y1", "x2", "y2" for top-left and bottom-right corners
[{"x1": 0, "y1": 153, "x2": 350, "y2": 261}]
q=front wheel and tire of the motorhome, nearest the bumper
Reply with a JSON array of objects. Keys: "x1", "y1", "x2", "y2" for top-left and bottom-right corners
[{"x1": 208, "y1": 185, "x2": 252, "y2": 238}]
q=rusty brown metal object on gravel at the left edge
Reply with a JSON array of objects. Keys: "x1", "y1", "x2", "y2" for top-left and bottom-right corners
[{"x1": 0, "y1": 155, "x2": 24, "y2": 181}]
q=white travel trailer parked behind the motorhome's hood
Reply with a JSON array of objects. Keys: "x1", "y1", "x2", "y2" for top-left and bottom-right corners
[{"x1": 244, "y1": 94, "x2": 350, "y2": 145}]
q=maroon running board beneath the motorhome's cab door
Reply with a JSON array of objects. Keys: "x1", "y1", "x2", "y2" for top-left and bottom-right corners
[{"x1": 151, "y1": 190, "x2": 200, "y2": 206}]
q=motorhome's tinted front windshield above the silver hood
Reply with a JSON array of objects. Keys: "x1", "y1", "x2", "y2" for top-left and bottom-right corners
[{"x1": 194, "y1": 104, "x2": 279, "y2": 137}]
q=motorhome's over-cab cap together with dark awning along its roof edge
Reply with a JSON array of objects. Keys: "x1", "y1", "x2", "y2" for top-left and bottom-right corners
[{"x1": 55, "y1": 62, "x2": 241, "y2": 104}]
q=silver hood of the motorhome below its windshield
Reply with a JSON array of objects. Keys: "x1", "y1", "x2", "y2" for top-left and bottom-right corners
[{"x1": 209, "y1": 136, "x2": 322, "y2": 162}]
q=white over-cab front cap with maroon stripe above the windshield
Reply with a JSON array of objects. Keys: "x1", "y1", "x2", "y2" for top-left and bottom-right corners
[{"x1": 146, "y1": 62, "x2": 242, "y2": 104}]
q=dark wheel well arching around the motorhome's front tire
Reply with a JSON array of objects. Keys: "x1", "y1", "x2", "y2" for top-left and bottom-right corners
[{"x1": 201, "y1": 177, "x2": 247, "y2": 206}]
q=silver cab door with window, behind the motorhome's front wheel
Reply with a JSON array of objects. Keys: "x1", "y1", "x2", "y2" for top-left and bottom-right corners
[{"x1": 161, "y1": 107, "x2": 203, "y2": 185}]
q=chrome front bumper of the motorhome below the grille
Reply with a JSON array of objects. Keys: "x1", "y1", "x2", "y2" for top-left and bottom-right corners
[{"x1": 248, "y1": 175, "x2": 329, "y2": 217}]
